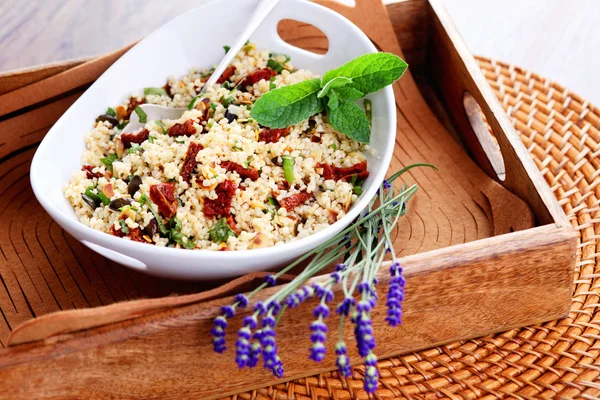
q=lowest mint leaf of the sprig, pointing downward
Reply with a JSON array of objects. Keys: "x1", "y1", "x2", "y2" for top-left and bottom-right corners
[{"x1": 327, "y1": 101, "x2": 371, "y2": 143}]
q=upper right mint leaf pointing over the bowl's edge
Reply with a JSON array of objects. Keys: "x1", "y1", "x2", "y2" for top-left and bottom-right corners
[{"x1": 321, "y1": 53, "x2": 408, "y2": 94}]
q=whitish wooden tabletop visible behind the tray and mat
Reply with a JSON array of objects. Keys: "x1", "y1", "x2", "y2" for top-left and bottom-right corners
[{"x1": 0, "y1": 0, "x2": 600, "y2": 105}]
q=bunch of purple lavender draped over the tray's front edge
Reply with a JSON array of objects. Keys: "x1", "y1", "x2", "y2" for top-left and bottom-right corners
[{"x1": 211, "y1": 164, "x2": 435, "y2": 393}]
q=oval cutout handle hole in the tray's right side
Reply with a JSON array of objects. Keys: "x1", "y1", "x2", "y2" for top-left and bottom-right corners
[{"x1": 463, "y1": 91, "x2": 506, "y2": 181}]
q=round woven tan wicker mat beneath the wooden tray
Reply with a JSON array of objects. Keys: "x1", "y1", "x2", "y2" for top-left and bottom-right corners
[{"x1": 218, "y1": 58, "x2": 600, "y2": 399}]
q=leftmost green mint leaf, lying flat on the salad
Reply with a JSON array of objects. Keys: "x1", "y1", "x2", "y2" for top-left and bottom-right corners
[{"x1": 250, "y1": 78, "x2": 323, "y2": 128}]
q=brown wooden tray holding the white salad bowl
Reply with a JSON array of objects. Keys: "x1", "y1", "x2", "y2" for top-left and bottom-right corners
[{"x1": 0, "y1": 0, "x2": 576, "y2": 398}]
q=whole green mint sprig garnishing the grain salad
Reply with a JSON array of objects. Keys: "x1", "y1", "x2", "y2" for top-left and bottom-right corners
[{"x1": 250, "y1": 53, "x2": 408, "y2": 143}]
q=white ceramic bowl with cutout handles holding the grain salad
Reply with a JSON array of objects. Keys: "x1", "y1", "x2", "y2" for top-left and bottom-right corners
[{"x1": 31, "y1": 0, "x2": 396, "y2": 280}]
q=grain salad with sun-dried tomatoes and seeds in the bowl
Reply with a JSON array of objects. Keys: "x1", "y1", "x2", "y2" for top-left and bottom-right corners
[{"x1": 64, "y1": 43, "x2": 369, "y2": 250}]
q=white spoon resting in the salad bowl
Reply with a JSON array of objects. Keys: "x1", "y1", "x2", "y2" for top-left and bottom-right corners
[{"x1": 121, "y1": 0, "x2": 280, "y2": 133}]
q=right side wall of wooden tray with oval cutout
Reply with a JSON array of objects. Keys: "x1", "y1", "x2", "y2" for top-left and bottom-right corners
[{"x1": 429, "y1": 0, "x2": 571, "y2": 227}]
